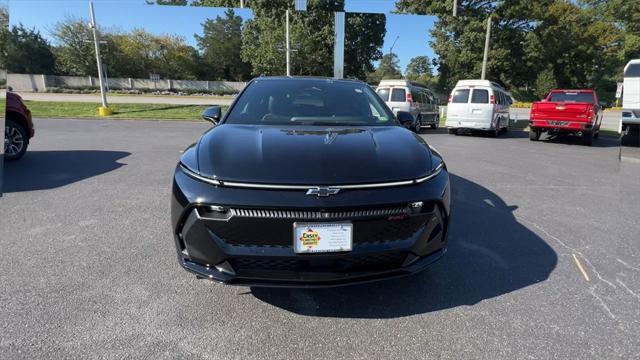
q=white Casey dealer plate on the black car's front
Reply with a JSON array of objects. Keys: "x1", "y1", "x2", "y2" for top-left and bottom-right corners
[{"x1": 293, "y1": 222, "x2": 353, "y2": 254}]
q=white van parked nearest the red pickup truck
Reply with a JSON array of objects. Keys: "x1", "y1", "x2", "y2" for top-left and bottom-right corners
[{"x1": 445, "y1": 80, "x2": 513, "y2": 136}]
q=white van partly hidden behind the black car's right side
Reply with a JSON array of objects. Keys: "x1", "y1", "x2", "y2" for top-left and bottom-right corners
[{"x1": 376, "y1": 79, "x2": 440, "y2": 132}]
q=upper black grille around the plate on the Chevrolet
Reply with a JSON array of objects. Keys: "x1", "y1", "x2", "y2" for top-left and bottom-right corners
[{"x1": 206, "y1": 207, "x2": 433, "y2": 248}]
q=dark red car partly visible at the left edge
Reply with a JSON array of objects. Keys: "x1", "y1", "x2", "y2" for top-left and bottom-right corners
[{"x1": 4, "y1": 91, "x2": 35, "y2": 161}]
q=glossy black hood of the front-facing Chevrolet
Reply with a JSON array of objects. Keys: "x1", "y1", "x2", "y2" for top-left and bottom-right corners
[{"x1": 198, "y1": 124, "x2": 431, "y2": 185}]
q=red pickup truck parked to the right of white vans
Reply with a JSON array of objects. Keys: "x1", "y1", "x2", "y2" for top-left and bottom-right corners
[{"x1": 529, "y1": 90, "x2": 603, "y2": 145}]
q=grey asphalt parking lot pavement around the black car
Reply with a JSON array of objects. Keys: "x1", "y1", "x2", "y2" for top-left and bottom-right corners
[{"x1": 0, "y1": 120, "x2": 640, "y2": 359}]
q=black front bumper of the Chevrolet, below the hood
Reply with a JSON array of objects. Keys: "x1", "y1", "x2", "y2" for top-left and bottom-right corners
[{"x1": 172, "y1": 168, "x2": 450, "y2": 287}]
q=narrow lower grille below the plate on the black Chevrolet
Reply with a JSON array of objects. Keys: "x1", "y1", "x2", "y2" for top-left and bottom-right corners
[{"x1": 230, "y1": 252, "x2": 407, "y2": 273}]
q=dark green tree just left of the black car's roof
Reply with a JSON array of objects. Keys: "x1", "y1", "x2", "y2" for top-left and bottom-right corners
[{"x1": 195, "y1": 9, "x2": 251, "y2": 81}]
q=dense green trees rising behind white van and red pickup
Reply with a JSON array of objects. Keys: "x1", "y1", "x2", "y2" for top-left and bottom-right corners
[{"x1": 396, "y1": 0, "x2": 640, "y2": 100}]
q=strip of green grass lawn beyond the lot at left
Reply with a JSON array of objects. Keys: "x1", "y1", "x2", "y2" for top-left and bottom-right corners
[{"x1": 26, "y1": 101, "x2": 227, "y2": 120}]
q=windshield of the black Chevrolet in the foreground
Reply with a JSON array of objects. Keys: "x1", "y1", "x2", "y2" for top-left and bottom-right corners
[{"x1": 225, "y1": 79, "x2": 396, "y2": 126}]
